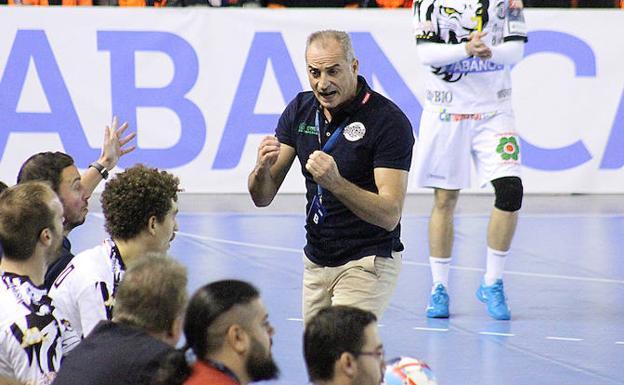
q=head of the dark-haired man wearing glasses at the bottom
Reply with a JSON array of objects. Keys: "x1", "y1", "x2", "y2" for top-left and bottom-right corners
[{"x1": 303, "y1": 306, "x2": 384, "y2": 385}]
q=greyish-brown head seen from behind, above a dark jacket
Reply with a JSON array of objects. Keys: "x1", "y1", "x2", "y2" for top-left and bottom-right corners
[{"x1": 113, "y1": 256, "x2": 187, "y2": 346}]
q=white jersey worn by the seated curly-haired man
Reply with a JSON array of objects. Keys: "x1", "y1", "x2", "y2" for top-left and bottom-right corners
[{"x1": 50, "y1": 239, "x2": 126, "y2": 337}]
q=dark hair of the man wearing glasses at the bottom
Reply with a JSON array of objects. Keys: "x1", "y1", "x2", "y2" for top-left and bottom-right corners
[{"x1": 303, "y1": 306, "x2": 377, "y2": 382}]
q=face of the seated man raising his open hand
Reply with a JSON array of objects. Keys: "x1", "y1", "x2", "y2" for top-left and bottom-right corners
[{"x1": 58, "y1": 165, "x2": 89, "y2": 232}]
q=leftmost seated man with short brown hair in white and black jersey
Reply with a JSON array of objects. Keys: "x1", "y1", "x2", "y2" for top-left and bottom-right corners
[{"x1": 0, "y1": 182, "x2": 80, "y2": 385}]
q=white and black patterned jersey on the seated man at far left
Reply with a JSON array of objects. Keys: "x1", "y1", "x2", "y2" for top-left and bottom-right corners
[{"x1": 0, "y1": 273, "x2": 80, "y2": 385}]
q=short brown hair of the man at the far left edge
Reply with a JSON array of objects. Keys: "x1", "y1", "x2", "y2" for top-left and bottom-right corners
[{"x1": 0, "y1": 182, "x2": 56, "y2": 261}]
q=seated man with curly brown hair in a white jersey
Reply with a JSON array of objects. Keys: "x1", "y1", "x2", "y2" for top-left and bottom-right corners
[{"x1": 50, "y1": 165, "x2": 179, "y2": 336}]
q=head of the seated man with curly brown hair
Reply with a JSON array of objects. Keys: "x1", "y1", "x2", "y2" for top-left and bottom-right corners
[{"x1": 100, "y1": 164, "x2": 180, "y2": 253}]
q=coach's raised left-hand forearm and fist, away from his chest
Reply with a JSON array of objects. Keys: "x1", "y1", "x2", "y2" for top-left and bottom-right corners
[{"x1": 247, "y1": 136, "x2": 296, "y2": 207}]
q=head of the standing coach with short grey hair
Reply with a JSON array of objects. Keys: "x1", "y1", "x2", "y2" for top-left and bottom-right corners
[{"x1": 305, "y1": 30, "x2": 358, "y2": 111}]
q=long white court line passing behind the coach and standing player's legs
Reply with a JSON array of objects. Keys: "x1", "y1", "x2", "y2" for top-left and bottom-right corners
[{"x1": 176, "y1": 231, "x2": 624, "y2": 285}]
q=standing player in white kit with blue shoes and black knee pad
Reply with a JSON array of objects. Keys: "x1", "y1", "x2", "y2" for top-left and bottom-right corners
[{"x1": 413, "y1": 0, "x2": 527, "y2": 320}]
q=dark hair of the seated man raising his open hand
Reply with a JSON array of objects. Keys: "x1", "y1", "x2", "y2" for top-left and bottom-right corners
[{"x1": 17, "y1": 151, "x2": 74, "y2": 194}]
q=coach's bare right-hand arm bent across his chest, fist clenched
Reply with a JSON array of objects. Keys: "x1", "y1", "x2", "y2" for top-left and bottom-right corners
[{"x1": 306, "y1": 151, "x2": 408, "y2": 231}]
